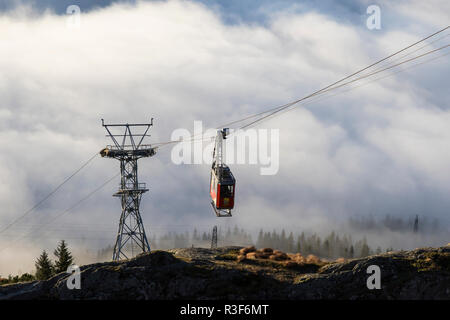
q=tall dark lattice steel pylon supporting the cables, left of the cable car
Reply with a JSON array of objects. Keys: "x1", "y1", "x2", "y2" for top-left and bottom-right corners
[{"x1": 100, "y1": 118, "x2": 156, "y2": 261}]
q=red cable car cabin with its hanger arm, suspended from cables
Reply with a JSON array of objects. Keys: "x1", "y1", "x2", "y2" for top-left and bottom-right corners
[{"x1": 210, "y1": 128, "x2": 236, "y2": 217}]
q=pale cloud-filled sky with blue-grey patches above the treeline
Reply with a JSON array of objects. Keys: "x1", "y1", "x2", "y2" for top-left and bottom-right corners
[{"x1": 0, "y1": 0, "x2": 450, "y2": 275}]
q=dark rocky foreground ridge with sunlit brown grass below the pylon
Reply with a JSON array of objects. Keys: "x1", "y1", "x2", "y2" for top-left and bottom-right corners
[{"x1": 0, "y1": 246, "x2": 450, "y2": 299}]
